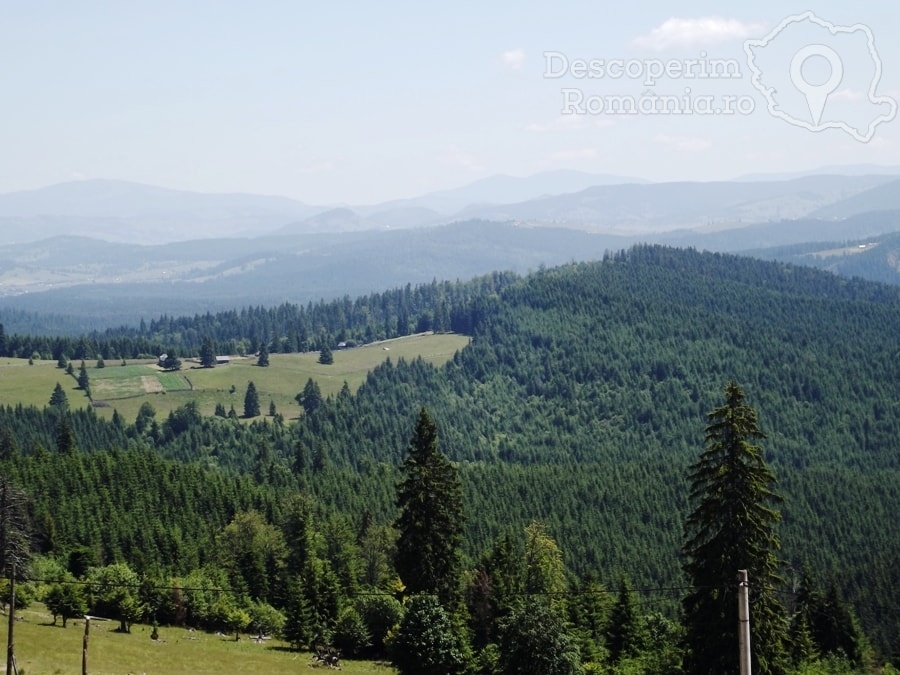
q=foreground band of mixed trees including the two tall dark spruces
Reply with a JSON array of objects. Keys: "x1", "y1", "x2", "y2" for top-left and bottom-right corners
[{"x1": 0, "y1": 398, "x2": 875, "y2": 675}]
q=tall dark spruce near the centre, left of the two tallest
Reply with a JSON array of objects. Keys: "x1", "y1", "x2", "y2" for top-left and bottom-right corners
[{"x1": 394, "y1": 408, "x2": 464, "y2": 603}]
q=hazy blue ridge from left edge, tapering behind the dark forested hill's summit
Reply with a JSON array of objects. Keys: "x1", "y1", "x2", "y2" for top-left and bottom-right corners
[{"x1": 0, "y1": 221, "x2": 631, "y2": 325}]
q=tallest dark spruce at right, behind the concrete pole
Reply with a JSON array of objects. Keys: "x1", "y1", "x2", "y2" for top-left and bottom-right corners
[{"x1": 683, "y1": 382, "x2": 787, "y2": 675}]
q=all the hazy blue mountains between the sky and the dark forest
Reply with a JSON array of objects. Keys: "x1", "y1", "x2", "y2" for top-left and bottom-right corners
[{"x1": 0, "y1": 166, "x2": 900, "y2": 325}]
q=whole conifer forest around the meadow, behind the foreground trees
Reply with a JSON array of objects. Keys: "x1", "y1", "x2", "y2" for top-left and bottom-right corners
[{"x1": 0, "y1": 246, "x2": 900, "y2": 672}]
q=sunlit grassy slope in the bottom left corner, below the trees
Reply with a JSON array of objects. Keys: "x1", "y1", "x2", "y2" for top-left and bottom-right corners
[{"x1": 7, "y1": 604, "x2": 396, "y2": 675}]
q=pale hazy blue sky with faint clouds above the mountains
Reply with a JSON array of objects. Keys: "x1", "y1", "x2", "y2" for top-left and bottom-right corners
[{"x1": 0, "y1": 0, "x2": 900, "y2": 204}]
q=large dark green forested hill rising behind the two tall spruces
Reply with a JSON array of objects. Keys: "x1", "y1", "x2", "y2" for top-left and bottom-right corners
[{"x1": 5, "y1": 247, "x2": 900, "y2": 651}]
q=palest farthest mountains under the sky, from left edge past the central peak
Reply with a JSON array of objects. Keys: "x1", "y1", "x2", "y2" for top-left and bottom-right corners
[{"x1": 0, "y1": 171, "x2": 639, "y2": 244}]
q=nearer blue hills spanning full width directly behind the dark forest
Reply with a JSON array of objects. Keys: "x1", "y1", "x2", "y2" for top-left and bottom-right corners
[{"x1": 0, "y1": 209, "x2": 900, "y2": 334}]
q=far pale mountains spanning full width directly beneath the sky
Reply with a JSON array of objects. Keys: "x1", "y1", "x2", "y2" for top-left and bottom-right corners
[{"x1": 7, "y1": 167, "x2": 900, "y2": 245}]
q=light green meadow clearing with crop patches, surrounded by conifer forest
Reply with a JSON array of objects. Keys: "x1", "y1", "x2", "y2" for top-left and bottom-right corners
[{"x1": 0, "y1": 334, "x2": 469, "y2": 421}]
